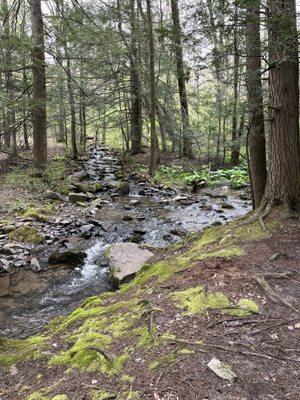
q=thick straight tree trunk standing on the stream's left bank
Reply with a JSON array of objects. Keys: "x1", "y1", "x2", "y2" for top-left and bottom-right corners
[{"x1": 30, "y1": 0, "x2": 47, "y2": 168}]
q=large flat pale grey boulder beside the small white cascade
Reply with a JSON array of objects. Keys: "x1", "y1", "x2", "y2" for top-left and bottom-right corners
[{"x1": 106, "y1": 243, "x2": 153, "y2": 287}]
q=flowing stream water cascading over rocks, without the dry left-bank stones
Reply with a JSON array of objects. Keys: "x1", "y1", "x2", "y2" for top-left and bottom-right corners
[{"x1": 0, "y1": 147, "x2": 251, "y2": 338}]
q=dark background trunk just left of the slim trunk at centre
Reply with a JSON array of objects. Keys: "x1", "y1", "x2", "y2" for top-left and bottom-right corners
[{"x1": 130, "y1": 0, "x2": 142, "y2": 154}]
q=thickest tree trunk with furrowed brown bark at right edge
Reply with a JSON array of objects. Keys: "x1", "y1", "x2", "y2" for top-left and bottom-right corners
[{"x1": 261, "y1": 0, "x2": 300, "y2": 210}]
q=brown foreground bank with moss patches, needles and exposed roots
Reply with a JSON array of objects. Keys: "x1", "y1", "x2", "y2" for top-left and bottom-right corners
[{"x1": 0, "y1": 147, "x2": 300, "y2": 400}]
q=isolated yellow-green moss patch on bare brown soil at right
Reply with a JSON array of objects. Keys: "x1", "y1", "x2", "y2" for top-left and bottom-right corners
[{"x1": 170, "y1": 286, "x2": 259, "y2": 317}]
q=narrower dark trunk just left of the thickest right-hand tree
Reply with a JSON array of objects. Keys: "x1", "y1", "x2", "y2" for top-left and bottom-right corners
[{"x1": 246, "y1": 0, "x2": 267, "y2": 208}]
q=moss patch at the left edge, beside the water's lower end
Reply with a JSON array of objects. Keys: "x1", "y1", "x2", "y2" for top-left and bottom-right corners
[{"x1": 0, "y1": 336, "x2": 49, "y2": 368}]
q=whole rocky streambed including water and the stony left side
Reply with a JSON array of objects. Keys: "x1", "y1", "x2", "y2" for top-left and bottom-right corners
[{"x1": 0, "y1": 147, "x2": 251, "y2": 337}]
